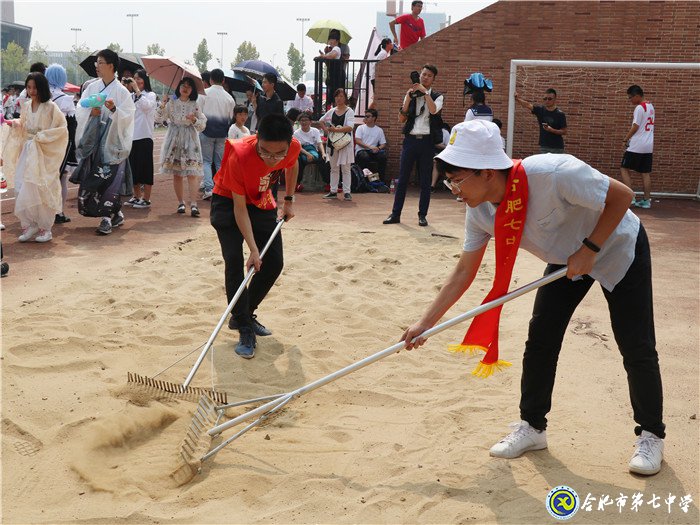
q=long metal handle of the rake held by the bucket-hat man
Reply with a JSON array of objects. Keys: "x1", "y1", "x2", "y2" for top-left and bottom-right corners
[{"x1": 207, "y1": 267, "x2": 567, "y2": 436}]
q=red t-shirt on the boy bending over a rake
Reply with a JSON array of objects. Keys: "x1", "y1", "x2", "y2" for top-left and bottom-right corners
[{"x1": 214, "y1": 135, "x2": 301, "y2": 210}]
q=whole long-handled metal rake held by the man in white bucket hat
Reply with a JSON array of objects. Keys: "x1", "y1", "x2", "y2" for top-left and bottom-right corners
[{"x1": 174, "y1": 268, "x2": 567, "y2": 481}]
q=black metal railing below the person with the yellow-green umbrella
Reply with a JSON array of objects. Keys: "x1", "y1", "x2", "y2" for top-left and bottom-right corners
[{"x1": 313, "y1": 58, "x2": 379, "y2": 120}]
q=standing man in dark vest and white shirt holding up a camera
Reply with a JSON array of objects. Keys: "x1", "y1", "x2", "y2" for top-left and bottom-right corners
[{"x1": 384, "y1": 64, "x2": 444, "y2": 226}]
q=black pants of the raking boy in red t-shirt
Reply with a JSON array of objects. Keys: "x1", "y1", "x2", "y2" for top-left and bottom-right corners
[{"x1": 210, "y1": 193, "x2": 284, "y2": 326}]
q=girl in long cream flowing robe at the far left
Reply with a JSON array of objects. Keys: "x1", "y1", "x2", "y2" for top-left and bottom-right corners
[{"x1": 2, "y1": 73, "x2": 68, "y2": 242}]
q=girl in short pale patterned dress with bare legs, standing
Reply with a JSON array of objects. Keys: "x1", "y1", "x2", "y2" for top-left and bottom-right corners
[{"x1": 156, "y1": 77, "x2": 207, "y2": 217}]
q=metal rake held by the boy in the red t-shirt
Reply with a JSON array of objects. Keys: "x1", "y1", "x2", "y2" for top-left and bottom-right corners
[{"x1": 127, "y1": 220, "x2": 284, "y2": 405}]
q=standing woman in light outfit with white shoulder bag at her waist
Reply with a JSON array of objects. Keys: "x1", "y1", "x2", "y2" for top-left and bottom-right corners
[{"x1": 319, "y1": 88, "x2": 355, "y2": 201}]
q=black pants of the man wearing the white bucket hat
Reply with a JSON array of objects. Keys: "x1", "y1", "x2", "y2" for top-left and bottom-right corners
[{"x1": 520, "y1": 224, "x2": 666, "y2": 438}]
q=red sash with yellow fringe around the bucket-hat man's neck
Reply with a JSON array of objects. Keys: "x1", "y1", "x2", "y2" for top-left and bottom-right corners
[{"x1": 448, "y1": 160, "x2": 527, "y2": 377}]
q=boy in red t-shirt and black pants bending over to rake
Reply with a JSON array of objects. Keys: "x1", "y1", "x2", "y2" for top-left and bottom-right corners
[{"x1": 210, "y1": 114, "x2": 301, "y2": 359}]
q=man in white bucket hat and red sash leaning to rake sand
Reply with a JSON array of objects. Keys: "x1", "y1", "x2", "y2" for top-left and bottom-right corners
[{"x1": 401, "y1": 120, "x2": 666, "y2": 475}]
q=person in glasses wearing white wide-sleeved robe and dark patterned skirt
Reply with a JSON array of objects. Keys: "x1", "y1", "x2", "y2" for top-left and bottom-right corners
[{"x1": 75, "y1": 49, "x2": 136, "y2": 235}]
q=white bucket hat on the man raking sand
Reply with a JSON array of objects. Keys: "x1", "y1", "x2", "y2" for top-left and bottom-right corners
[{"x1": 435, "y1": 120, "x2": 513, "y2": 170}]
